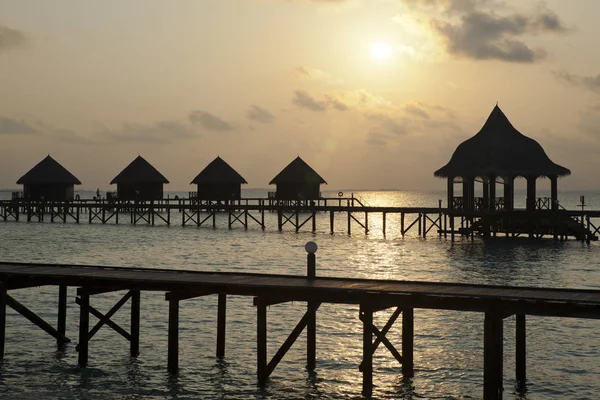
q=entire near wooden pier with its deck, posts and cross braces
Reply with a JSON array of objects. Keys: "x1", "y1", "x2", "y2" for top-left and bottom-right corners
[{"x1": 0, "y1": 252, "x2": 600, "y2": 400}]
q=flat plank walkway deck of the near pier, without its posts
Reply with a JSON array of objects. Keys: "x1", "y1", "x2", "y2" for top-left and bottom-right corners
[{"x1": 0, "y1": 263, "x2": 600, "y2": 318}]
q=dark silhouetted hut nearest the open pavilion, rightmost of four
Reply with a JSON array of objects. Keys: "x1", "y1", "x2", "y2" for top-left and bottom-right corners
[{"x1": 269, "y1": 156, "x2": 327, "y2": 200}]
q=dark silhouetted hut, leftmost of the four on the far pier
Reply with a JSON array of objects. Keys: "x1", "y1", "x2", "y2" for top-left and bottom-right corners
[{"x1": 17, "y1": 155, "x2": 81, "y2": 201}]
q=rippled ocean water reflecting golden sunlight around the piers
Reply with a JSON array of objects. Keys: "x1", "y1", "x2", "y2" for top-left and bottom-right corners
[{"x1": 0, "y1": 190, "x2": 600, "y2": 399}]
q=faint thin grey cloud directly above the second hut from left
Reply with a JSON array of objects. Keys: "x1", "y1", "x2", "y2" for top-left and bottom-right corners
[{"x1": 100, "y1": 121, "x2": 197, "y2": 143}]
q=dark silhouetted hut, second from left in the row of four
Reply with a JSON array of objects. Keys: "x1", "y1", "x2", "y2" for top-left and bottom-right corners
[{"x1": 110, "y1": 156, "x2": 169, "y2": 200}]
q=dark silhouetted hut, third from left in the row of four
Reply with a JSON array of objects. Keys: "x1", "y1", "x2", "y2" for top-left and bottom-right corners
[{"x1": 190, "y1": 157, "x2": 248, "y2": 200}]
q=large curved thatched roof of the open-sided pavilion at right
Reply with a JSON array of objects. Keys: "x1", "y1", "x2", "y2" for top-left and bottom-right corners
[{"x1": 434, "y1": 105, "x2": 571, "y2": 177}]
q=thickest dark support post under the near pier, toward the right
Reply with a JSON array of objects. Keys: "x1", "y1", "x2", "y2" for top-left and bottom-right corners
[{"x1": 483, "y1": 311, "x2": 504, "y2": 400}]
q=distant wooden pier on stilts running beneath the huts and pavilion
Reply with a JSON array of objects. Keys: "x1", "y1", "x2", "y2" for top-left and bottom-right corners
[{"x1": 0, "y1": 196, "x2": 600, "y2": 242}]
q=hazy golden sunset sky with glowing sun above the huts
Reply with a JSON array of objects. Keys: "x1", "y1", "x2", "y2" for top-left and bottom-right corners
[{"x1": 0, "y1": 0, "x2": 600, "y2": 190}]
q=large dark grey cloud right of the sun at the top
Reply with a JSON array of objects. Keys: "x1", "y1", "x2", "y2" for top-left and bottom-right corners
[{"x1": 403, "y1": 0, "x2": 570, "y2": 63}]
